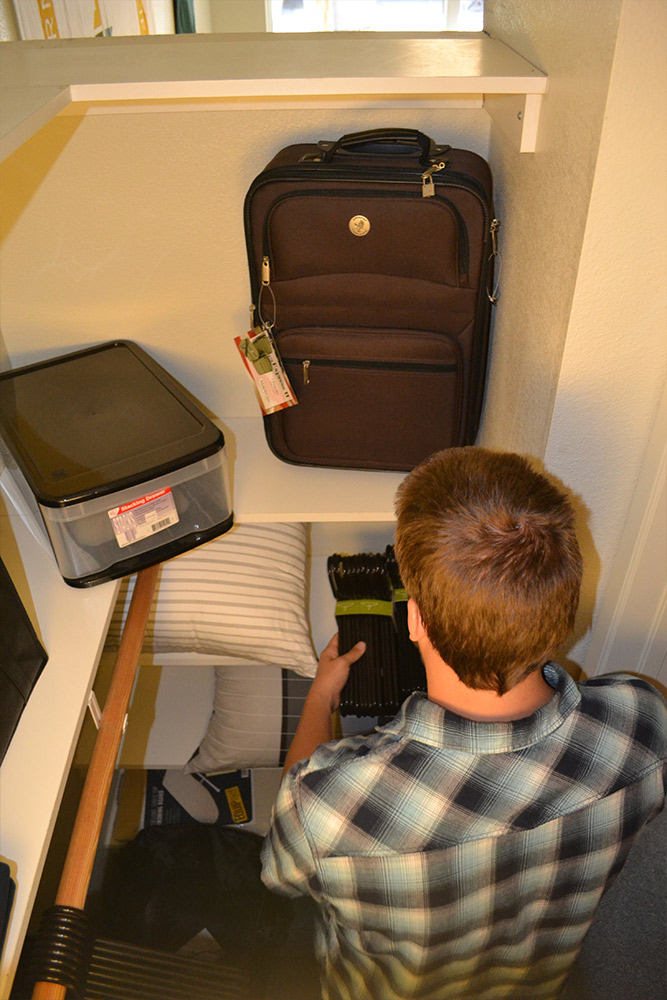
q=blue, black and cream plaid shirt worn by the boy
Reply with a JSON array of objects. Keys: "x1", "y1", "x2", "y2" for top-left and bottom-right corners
[{"x1": 262, "y1": 664, "x2": 667, "y2": 1000}]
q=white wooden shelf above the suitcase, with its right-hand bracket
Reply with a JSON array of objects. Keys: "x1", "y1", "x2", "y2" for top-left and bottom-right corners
[{"x1": 0, "y1": 32, "x2": 547, "y2": 158}]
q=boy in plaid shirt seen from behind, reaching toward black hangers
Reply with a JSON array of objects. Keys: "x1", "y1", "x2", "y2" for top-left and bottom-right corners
[{"x1": 262, "y1": 448, "x2": 667, "y2": 1000}]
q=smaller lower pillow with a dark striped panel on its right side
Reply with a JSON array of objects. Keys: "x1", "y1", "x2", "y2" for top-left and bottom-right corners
[{"x1": 185, "y1": 664, "x2": 311, "y2": 774}]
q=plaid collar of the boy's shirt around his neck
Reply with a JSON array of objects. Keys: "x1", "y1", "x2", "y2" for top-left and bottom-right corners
[{"x1": 380, "y1": 663, "x2": 581, "y2": 754}]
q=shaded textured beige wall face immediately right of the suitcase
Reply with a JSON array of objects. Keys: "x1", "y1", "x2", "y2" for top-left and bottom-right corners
[{"x1": 483, "y1": 0, "x2": 621, "y2": 458}]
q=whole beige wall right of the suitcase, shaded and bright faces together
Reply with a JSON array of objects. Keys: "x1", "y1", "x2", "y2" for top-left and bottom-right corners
[{"x1": 483, "y1": 0, "x2": 667, "y2": 669}]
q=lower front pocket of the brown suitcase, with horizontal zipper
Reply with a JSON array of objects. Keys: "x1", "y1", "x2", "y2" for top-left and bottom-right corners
[{"x1": 267, "y1": 329, "x2": 462, "y2": 470}]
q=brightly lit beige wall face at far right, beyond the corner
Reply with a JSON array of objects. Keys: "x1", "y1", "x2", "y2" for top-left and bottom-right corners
[{"x1": 546, "y1": 0, "x2": 667, "y2": 672}]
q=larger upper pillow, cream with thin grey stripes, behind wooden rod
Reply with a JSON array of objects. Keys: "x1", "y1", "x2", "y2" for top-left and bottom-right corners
[{"x1": 107, "y1": 524, "x2": 317, "y2": 677}]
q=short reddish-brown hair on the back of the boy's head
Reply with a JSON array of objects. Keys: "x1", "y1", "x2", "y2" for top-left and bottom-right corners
[{"x1": 395, "y1": 447, "x2": 582, "y2": 694}]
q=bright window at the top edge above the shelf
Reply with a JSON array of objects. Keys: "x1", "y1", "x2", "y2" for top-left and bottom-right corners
[{"x1": 267, "y1": 0, "x2": 484, "y2": 31}]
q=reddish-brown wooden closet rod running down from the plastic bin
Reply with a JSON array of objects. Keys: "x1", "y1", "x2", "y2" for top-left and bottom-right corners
[{"x1": 32, "y1": 564, "x2": 160, "y2": 1000}]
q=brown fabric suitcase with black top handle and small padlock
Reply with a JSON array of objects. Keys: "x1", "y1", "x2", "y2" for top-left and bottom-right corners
[{"x1": 244, "y1": 129, "x2": 499, "y2": 470}]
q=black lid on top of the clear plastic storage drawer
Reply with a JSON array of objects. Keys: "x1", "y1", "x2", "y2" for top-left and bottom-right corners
[{"x1": 0, "y1": 340, "x2": 225, "y2": 507}]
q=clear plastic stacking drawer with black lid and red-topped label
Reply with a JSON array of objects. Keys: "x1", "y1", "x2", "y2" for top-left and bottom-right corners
[{"x1": 0, "y1": 341, "x2": 233, "y2": 587}]
